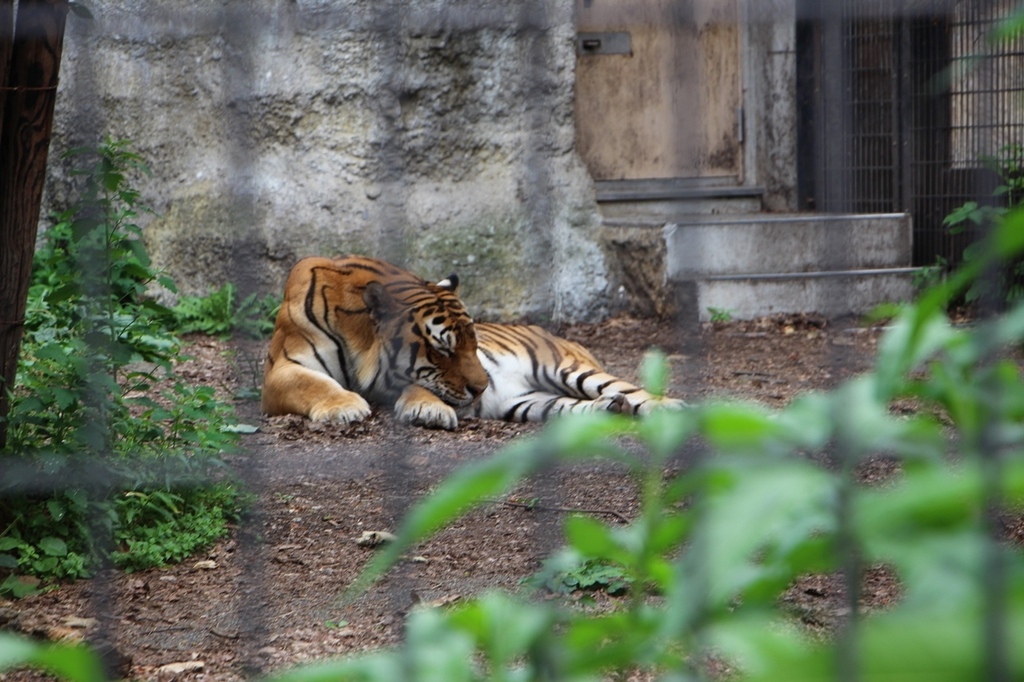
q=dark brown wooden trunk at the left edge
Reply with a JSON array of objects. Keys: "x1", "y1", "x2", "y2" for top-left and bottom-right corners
[{"x1": 0, "y1": 0, "x2": 68, "y2": 447}]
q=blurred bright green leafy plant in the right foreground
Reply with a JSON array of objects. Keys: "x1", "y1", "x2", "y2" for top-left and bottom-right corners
[{"x1": 258, "y1": 204, "x2": 1024, "y2": 682}]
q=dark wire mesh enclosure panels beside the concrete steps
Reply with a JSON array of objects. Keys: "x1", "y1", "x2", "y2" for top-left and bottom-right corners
[{"x1": 803, "y1": 2, "x2": 1022, "y2": 265}]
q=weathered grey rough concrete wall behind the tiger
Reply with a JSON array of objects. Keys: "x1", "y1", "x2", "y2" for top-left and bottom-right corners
[{"x1": 46, "y1": 0, "x2": 607, "y2": 319}]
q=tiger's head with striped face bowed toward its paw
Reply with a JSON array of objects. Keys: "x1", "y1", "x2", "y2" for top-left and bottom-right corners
[{"x1": 362, "y1": 274, "x2": 487, "y2": 408}]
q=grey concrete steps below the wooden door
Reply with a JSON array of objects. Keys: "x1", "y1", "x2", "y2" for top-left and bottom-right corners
[{"x1": 598, "y1": 183, "x2": 916, "y2": 321}]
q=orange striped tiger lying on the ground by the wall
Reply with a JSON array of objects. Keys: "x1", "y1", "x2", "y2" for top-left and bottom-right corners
[{"x1": 262, "y1": 256, "x2": 683, "y2": 429}]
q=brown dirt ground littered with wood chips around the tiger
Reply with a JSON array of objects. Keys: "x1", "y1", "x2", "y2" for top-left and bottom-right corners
[{"x1": 0, "y1": 316, "x2": 898, "y2": 681}]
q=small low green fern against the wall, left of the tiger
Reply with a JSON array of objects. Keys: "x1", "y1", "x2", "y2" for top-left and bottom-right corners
[{"x1": 172, "y1": 283, "x2": 281, "y2": 337}]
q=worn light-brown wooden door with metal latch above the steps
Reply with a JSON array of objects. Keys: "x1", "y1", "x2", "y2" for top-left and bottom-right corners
[{"x1": 575, "y1": 0, "x2": 742, "y2": 182}]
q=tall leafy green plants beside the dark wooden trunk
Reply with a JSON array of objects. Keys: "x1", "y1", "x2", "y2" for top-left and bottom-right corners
[{"x1": 0, "y1": 139, "x2": 243, "y2": 595}]
